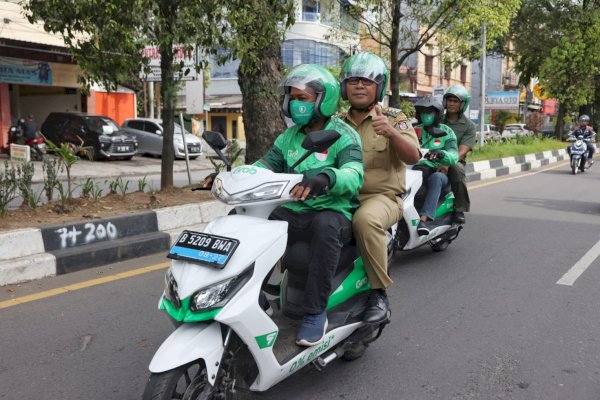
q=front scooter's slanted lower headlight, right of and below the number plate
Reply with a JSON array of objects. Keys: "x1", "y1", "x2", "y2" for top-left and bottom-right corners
[{"x1": 190, "y1": 266, "x2": 254, "y2": 312}]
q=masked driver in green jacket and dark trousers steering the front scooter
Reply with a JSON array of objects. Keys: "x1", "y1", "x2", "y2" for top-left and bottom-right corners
[{"x1": 204, "y1": 65, "x2": 363, "y2": 346}]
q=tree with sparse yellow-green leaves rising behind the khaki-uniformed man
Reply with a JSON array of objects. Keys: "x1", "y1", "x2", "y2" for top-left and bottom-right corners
[{"x1": 328, "y1": 0, "x2": 521, "y2": 107}]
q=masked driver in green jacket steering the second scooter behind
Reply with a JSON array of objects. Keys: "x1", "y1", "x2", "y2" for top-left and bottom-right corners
[{"x1": 413, "y1": 96, "x2": 458, "y2": 236}]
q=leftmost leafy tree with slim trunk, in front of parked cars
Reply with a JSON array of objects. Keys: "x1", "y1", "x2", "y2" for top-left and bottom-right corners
[{"x1": 24, "y1": 0, "x2": 220, "y2": 189}]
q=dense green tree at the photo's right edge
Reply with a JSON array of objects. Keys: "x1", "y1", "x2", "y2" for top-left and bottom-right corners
[{"x1": 512, "y1": 0, "x2": 600, "y2": 137}]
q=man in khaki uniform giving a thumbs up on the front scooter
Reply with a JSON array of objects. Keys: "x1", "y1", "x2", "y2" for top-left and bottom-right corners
[{"x1": 340, "y1": 52, "x2": 420, "y2": 323}]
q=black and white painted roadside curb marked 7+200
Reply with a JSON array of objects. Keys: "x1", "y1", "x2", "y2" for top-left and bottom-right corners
[{"x1": 0, "y1": 149, "x2": 568, "y2": 286}]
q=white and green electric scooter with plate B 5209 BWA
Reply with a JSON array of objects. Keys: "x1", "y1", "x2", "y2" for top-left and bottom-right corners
[{"x1": 143, "y1": 131, "x2": 388, "y2": 400}]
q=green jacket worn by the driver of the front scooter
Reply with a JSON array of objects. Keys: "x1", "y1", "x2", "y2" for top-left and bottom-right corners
[{"x1": 254, "y1": 117, "x2": 364, "y2": 220}]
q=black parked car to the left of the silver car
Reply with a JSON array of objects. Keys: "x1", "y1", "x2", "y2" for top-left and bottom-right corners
[{"x1": 42, "y1": 112, "x2": 138, "y2": 160}]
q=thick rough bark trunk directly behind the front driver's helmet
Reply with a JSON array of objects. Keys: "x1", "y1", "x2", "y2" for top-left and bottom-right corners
[{"x1": 238, "y1": 36, "x2": 286, "y2": 164}]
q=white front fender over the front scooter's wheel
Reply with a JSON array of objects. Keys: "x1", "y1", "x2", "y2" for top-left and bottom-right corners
[{"x1": 149, "y1": 321, "x2": 224, "y2": 385}]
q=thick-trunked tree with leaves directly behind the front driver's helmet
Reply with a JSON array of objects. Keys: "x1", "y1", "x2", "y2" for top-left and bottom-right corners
[{"x1": 213, "y1": 0, "x2": 294, "y2": 163}]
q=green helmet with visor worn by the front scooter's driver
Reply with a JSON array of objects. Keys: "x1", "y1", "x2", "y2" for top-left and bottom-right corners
[{"x1": 279, "y1": 64, "x2": 340, "y2": 118}]
